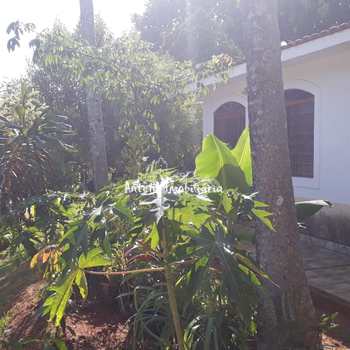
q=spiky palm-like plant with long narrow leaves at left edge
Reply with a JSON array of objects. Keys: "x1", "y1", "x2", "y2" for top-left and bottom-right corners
[{"x1": 0, "y1": 81, "x2": 72, "y2": 210}]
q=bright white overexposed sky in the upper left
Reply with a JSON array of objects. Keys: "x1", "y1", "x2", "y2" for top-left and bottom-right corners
[{"x1": 0, "y1": 0, "x2": 145, "y2": 80}]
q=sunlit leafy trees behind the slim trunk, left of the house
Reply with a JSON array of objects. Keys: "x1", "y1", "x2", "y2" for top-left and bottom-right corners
[{"x1": 0, "y1": 18, "x2": 232, "y2": 208}]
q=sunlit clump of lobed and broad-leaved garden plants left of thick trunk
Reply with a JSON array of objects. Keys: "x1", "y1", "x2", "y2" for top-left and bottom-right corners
[{"x1": 15, "y1": 132, "x2": 328, "y2": 349}]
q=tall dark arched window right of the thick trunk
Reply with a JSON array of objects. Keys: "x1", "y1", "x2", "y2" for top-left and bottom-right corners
[{"x1": 285, "y1": 89, "x2": 315, "y2": 178}]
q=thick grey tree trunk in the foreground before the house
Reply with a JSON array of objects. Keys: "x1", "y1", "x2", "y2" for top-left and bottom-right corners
[{"x1": 241, "y1": 0, "x2": 318, "y2": 350}]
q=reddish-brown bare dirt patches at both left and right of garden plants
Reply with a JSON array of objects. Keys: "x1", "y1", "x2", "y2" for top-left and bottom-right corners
[{"x1": 0, "y1": 274, "x2": 350, "y2": 350}]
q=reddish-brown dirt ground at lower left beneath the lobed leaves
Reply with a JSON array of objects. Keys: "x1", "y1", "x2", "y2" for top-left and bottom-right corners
[{"x1": 0, "y1": 282, "x2": 128, "y2": 350}]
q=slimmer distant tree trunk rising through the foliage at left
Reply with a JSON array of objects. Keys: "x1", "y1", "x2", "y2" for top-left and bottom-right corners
[{"x1": 80, "y1": 0, "x2": 108, "y2": 190}]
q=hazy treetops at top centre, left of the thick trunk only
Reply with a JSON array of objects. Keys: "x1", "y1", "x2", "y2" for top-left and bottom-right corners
[{"x1": 134, "y1": 0, "x2": 241, "y2": 63}]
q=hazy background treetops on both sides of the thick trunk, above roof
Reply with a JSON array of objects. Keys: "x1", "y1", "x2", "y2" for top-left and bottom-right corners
[{"x1": 134, "y1": 0, "x2": 350, "y2": 62}]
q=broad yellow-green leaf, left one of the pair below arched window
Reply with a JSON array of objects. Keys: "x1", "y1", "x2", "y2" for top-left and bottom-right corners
[{"x1": 195, "y1": 135, "x2": 249, "y2": 193}]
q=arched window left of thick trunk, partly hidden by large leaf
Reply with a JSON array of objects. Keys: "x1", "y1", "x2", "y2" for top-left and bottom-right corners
[{"x1": 214, "y1": 102, "x2": 245, "y2": 147}]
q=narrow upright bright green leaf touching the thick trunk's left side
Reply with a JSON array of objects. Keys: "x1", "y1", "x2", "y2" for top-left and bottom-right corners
[{"x1": 231, "y1": 128, "x2": 253, "y2": 186}]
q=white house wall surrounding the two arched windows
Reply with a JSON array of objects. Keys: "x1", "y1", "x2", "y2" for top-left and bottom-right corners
[{"x1": 203, "y1": 44, "x2": 350, "y2": 245}]
